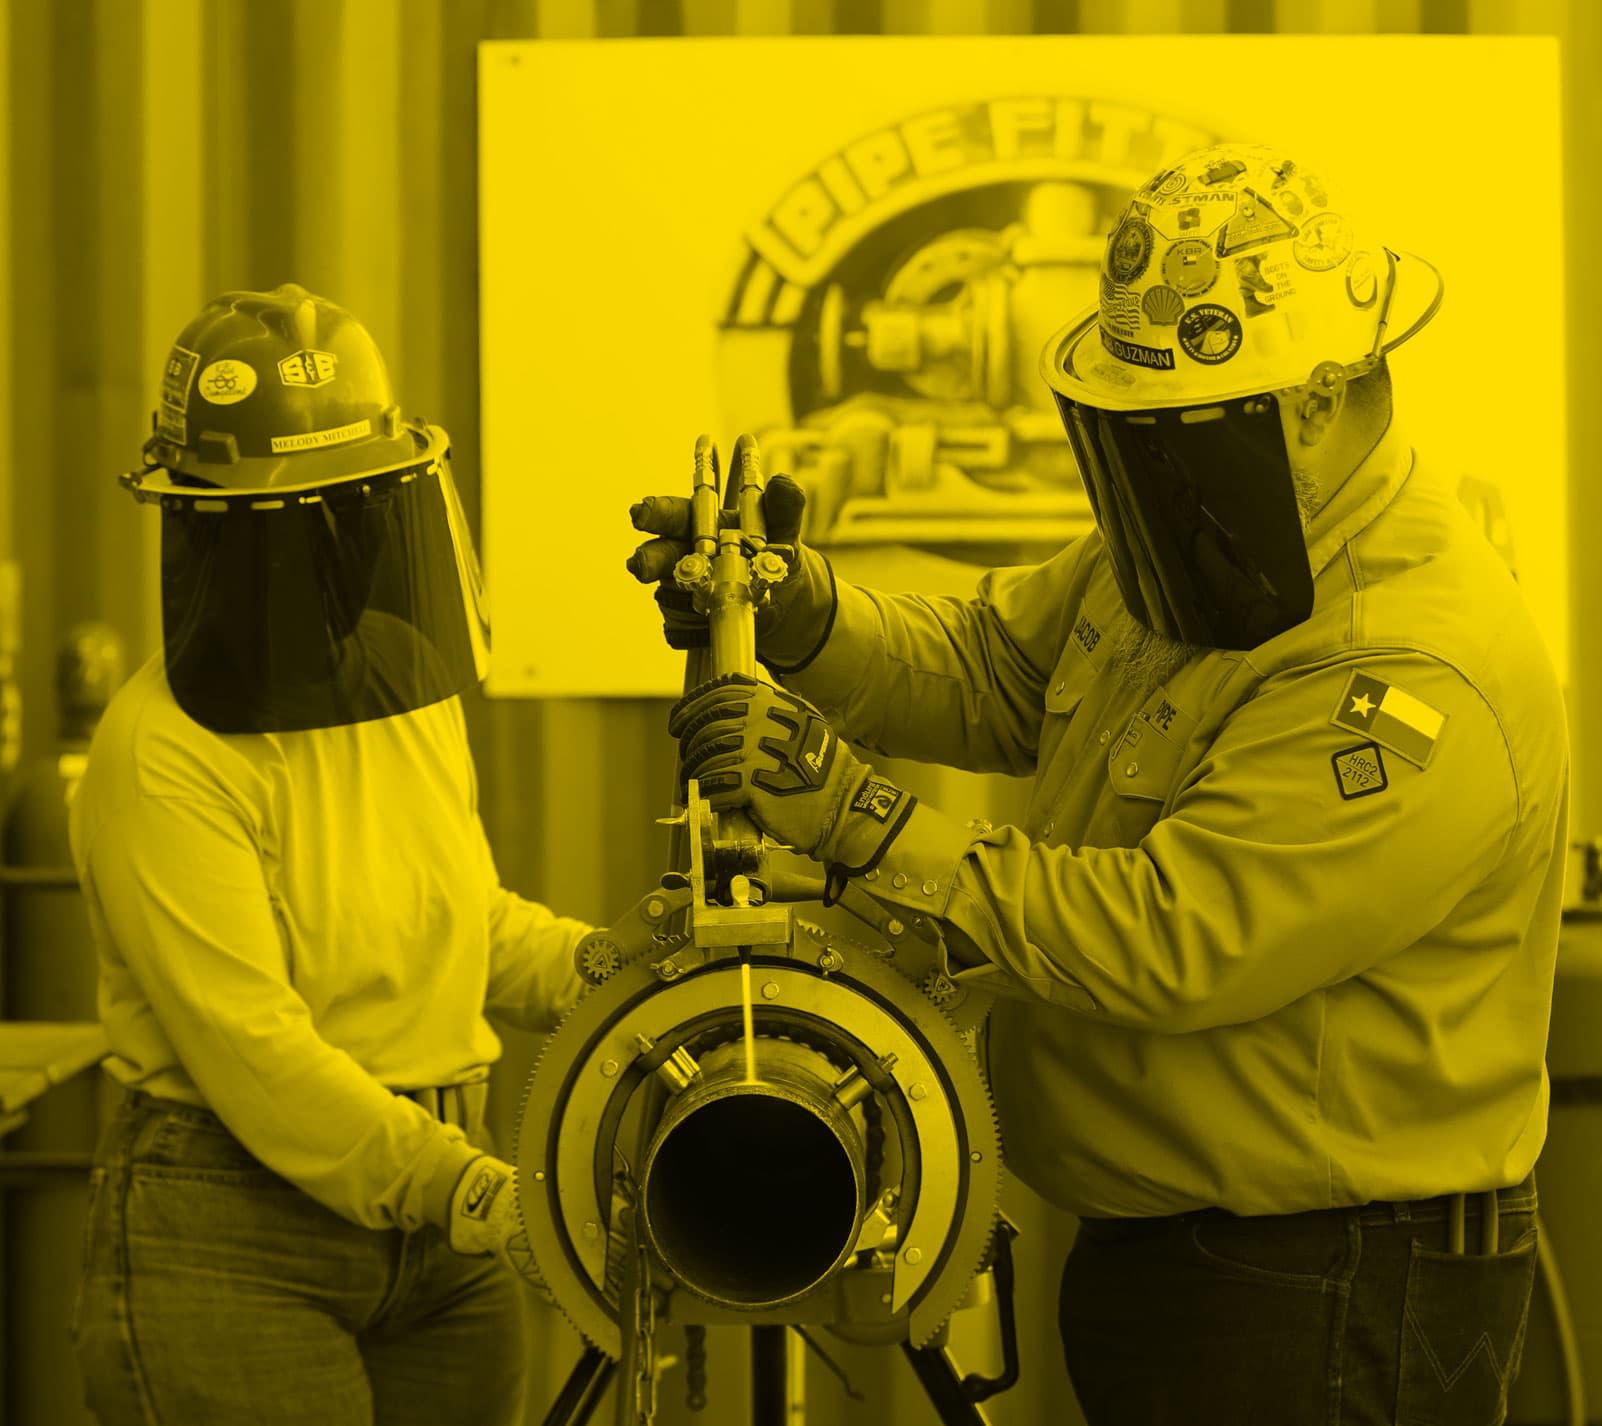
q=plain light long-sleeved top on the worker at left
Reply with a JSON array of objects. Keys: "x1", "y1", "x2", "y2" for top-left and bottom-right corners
[{"x1": 70, "y1": 657, "x2": 590, "y2": 1229}]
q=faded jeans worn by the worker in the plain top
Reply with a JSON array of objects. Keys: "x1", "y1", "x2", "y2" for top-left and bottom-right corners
[{"x1": 72, "y1": 1094, "x2": 529, "y2": 1426}]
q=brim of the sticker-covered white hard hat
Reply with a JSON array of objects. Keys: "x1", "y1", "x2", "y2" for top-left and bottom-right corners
[{"x1": 1040, "y1": 248, "x2": 1445, "y2": 410}]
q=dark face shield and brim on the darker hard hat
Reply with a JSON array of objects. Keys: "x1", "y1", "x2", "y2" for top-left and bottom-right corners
[{"x1": 123, "y1": 428, "x2": 489, "y2": 734}]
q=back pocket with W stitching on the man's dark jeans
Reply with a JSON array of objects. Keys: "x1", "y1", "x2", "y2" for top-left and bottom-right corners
[{"x1": 1395, "y1": 1226, "x2": 1536, "y2": 1426}]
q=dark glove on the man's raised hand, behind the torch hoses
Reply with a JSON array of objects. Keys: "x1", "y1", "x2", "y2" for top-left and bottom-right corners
[{"x1": 628, "y1": 474, "x2": 835, "y2": 657}]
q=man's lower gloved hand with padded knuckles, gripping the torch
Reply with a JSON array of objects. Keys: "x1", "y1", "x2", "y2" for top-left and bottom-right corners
[{"x1": 668, "y1": 673, "x2": 918, "y2": 876}]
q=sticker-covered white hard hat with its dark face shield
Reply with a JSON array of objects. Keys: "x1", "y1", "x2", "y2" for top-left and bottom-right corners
[{"x1": 1041, "y1": 144, "x2": 1442, "y2": 649}]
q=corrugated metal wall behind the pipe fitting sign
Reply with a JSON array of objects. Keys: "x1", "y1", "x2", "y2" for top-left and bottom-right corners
[{"x1": 0, "y1": 0, "x2": 1602, "y2": 1421}]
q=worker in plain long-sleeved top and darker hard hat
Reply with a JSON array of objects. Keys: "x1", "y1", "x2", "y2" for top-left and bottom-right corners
[{"x1": 72, "y1": 285, "x2": 590, "y2": 1426}]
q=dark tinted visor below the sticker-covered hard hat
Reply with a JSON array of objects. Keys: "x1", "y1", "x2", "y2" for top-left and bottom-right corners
[{"x1": 1053, "y1": 393, "x2": 1312, "y2": 649}]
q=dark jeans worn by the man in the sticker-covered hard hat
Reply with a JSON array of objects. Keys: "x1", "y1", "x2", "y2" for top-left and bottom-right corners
[{"x1": 1059, "y1": 1176, "x2": 1536, "y2": 1426}]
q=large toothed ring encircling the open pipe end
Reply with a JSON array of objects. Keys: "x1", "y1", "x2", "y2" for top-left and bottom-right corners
[{"x1": 514, "y1": 928, "x2": 1001, "y2": 1357}]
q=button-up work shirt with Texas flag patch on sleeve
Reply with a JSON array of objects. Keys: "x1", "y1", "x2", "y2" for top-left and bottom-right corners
[{"x1": 764, "y1": 431, "x2": 1568, "y2": 1216}]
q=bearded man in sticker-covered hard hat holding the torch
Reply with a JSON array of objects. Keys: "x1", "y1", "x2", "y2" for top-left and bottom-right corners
[{"x1": 634, "y1": 144, "x2": 1568, "y2": 1426}]
